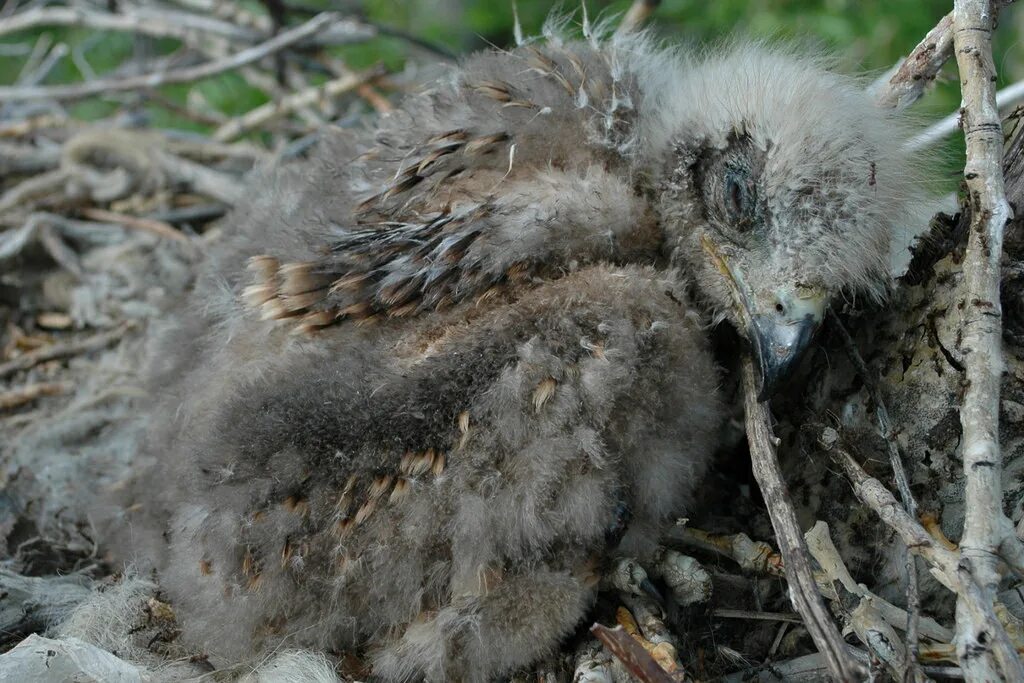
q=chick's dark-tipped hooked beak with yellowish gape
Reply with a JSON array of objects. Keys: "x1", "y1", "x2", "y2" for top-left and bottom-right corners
[{"x1": 701, "y1": 237, "x2": 827, "y2": 401}]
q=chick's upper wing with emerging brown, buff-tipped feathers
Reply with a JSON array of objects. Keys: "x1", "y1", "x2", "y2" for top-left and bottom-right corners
[{"x1": 243, "y1": 44, "x2": 632, "y2": 332}]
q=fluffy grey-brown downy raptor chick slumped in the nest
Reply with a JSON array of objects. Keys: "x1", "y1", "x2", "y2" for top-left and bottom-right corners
[{"x1": 112, "y1": 21, "x2": 920, "y2": 681}]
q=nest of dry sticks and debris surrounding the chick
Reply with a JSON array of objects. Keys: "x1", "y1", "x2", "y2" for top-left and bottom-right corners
[{"x1": 0, "y1": 0, "x2": 1024, "y2": 681}]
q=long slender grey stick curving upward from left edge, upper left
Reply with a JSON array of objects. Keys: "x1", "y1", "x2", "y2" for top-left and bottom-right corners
[{"x1": 0, "y1": 12, "x2": 342, "y2": 101}]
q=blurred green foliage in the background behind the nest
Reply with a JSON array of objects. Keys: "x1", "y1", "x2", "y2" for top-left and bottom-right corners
[{"x1": 0, "y1": 0, "x2": 1024, "y2": 170}]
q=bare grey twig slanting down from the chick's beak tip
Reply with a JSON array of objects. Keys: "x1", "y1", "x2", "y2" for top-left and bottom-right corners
[{"x1": 742, "y1": 356, "x2": 862, "y2": 681}]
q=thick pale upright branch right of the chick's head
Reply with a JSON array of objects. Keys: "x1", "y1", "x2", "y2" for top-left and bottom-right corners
[{"x1": 953, "y1": 0, "x2": 1024, "y2": 680}]
